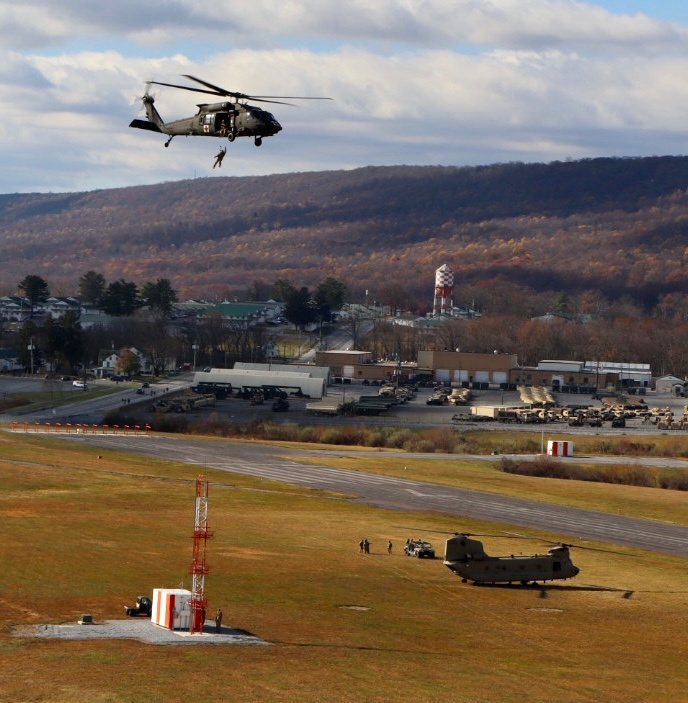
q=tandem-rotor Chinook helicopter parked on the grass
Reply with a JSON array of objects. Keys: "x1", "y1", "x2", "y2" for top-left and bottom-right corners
[{"x1": 444, "y1": 533, "x2": 623, "y2": 586}]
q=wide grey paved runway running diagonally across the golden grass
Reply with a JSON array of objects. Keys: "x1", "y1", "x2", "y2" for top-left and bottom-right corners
[{"x1": 47, "y1": 434, "x2": 688, "y2": 557}]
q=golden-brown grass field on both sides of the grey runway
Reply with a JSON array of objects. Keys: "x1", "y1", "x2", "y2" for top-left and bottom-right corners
[{"x1": 0, "y1": 434, "x2": 688, "y2": 703}]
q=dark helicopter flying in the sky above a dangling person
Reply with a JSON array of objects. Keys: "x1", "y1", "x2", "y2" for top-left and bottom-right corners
[{"x1": 129, "y1": 74, "x2": 332, "y2": 146}]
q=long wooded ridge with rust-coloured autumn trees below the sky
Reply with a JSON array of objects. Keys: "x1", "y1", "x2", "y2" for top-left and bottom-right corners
[{"x1": 0, "y1": 157, "x2": 688, "y2": 314}]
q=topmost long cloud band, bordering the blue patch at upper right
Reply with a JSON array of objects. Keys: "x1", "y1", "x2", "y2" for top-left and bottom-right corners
[{"x1": 5, "y1": 0, "x2": 688, "y2": 51}]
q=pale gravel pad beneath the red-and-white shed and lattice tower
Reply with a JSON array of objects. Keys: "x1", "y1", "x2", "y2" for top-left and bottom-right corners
[{"x1": 12, "y1": 618, "x2": 269, "y2": 645}]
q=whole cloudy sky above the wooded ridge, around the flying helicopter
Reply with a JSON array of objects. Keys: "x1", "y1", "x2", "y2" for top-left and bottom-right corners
[{"x1": 0, "y1": 0, "x2": 688, "y2": 193}]
